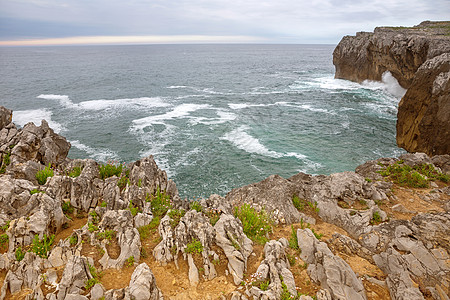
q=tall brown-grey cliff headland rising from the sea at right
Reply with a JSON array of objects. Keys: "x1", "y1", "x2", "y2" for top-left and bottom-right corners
[{"x1": 333, "y1": 21, "x2": 450, "y2": 155}]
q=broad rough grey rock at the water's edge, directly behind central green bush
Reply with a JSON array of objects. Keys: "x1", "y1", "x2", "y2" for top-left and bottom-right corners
[{"x1": 225, "y1": 175, "x2": 301, "y2": 224}]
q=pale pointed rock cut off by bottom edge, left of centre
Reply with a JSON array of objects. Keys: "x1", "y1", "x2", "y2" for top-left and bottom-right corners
[{"x1": 125, "y1": 263, "x2": 163, "y2": 300}]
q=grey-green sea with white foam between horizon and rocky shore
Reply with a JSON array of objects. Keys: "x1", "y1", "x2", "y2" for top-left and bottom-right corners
[{"x1": 0, "y1": 45, "x2": 404, "y2": 199}]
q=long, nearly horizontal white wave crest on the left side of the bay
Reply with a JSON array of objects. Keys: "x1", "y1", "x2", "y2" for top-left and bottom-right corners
[{"x1": 37, "y1": 94, "x2": 170, "y2": 110}]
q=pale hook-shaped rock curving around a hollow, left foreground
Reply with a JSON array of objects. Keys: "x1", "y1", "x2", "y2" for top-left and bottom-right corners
[{"x1": 99, "y1": 210, "x2": 141, "y2": 269}]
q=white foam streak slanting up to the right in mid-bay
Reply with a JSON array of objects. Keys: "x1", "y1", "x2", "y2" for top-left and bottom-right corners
[{"x1": 133, "y1": 103, "x2": 210, "y2": 130}]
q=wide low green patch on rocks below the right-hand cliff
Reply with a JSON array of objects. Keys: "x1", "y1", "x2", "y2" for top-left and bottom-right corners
[{"x1": 378, "y1": 160, "x2": 450, "y2": 188}]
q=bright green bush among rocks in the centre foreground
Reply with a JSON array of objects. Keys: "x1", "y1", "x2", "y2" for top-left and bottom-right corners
[{"x1": 234, "y1": 203, "x2": 272, "y2": 244}]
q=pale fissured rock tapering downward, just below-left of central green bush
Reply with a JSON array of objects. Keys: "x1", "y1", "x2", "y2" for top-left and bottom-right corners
[{"x1": 214, "y1": 214, "x2": 253, "y2": 285}]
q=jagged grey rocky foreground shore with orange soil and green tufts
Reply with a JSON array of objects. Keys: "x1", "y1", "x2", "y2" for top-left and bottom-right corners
[{"x1": 0, "y1": 107, "x2": 450, "y2": 300}]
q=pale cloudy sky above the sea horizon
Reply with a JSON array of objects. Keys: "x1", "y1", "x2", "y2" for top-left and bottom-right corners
[{"x1": 0, "y1": 0, "x2": 450, "y2": 46}]
